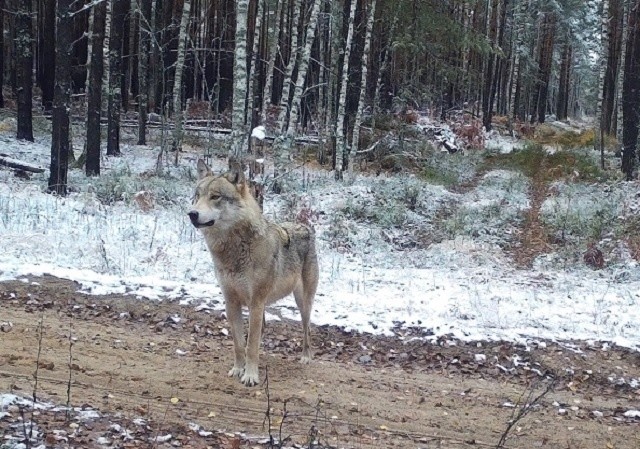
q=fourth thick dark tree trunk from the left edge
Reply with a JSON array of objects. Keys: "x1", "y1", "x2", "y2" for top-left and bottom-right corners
[{"x1": 107, "y1": 0, "x2": 129, "y2": 156}]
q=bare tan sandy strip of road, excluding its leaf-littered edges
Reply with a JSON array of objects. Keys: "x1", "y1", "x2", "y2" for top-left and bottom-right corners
[{"x1": 0, "y1": 279, "x2": 635, "y2": 448}]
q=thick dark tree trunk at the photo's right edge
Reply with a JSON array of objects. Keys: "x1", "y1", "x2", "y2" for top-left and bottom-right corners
[{"x1": 622, "y1": 0, "x2": 640, "y2": 181}]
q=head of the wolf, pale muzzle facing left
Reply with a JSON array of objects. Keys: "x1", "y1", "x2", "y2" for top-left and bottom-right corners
[{"x1": 188, "y1": 159, "x2": 260, "y2": 230}]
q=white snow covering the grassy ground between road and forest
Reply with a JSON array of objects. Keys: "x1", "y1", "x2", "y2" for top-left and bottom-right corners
[{"x1": 0, "y1": 126, "x2": 640, "y2": 348}]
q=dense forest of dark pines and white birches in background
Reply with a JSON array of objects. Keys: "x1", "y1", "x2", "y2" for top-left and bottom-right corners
[{"x1": 0, "y1": 0, "x2": 640, "y2": 193}]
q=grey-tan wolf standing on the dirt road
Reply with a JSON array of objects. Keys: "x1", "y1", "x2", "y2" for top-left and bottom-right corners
[{"x1": 188, "y1": 159, "x2": 319, "y2": 386}]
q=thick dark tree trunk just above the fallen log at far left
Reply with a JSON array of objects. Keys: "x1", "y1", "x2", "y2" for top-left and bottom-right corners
[{"x1": 14, "y1": 1, "x2": 33, "y2": 142}]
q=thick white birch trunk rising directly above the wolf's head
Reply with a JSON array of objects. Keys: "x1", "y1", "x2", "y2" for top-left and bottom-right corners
[{"x1": 229, "y1": 0, "x2": 249, "y2": 161}]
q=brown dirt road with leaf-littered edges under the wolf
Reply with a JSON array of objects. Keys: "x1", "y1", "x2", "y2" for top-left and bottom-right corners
[{"x1": 0, "y1": 277, "x2": 640, "y2": 449}]
